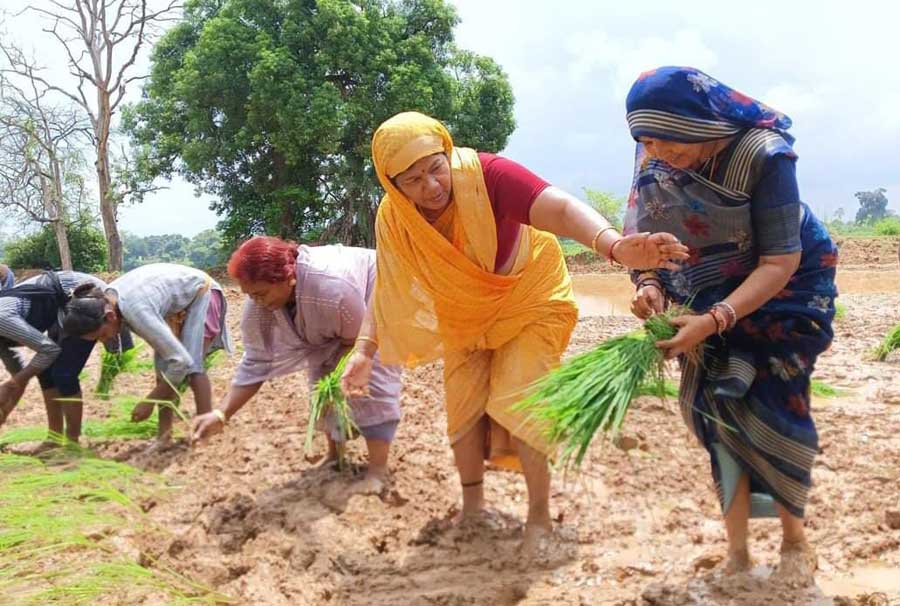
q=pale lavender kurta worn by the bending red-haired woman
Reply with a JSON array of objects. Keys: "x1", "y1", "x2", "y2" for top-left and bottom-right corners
[{"x1": 233, "y1": 245, "x2": 400, "y2": 434}]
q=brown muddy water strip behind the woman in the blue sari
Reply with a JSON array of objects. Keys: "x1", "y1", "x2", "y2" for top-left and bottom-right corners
[{"x1": 572, "y1": 270, "x2": 900, "y2": 318}]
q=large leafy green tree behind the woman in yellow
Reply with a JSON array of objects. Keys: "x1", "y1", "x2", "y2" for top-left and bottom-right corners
[{"x1": 123, "y1": 0, "x2": 515, "y2": 245}]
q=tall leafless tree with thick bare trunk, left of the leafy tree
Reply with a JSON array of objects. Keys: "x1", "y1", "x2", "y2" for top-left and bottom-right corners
[{"x1": 4, "y1": 0, "x2": 181, "y2": 271}]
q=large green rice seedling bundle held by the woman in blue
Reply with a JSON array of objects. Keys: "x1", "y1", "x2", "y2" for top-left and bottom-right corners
[{"x1": 516, "y1": 308, "x2": 686, "y2": 467}]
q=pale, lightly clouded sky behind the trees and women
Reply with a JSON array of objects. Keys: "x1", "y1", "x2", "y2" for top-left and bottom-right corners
[{"x1": 0, "y1": 0, "x2": 900, "y2": 236}]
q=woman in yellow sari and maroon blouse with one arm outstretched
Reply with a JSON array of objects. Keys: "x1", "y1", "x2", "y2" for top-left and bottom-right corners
[{"x1": 343, "y1": 112, "x2": 687, "y2": 550}]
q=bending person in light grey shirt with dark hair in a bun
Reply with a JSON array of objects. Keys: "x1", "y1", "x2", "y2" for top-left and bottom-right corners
[{"x1": 63, "y1": 263, "x2": 231, "y2": 442}]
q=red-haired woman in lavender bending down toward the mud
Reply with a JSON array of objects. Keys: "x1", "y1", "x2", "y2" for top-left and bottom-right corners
[{"x1": 194, "y1": 236, "x2": 400, "y2": 492}]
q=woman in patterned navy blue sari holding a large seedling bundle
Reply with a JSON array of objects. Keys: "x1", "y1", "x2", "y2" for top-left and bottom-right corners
[{"x1": 625, "y1": 67, "x2": 837, "y2": 582}]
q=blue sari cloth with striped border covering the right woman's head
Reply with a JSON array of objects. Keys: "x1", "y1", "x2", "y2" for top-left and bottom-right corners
[{"x1": 625, "y1": 67, "x2": 793, "y2": 143}]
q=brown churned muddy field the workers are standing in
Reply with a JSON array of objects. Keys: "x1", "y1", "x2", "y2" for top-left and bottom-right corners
[{"x1": 0, "y1": 239, "x2": 900, "y2": 606}]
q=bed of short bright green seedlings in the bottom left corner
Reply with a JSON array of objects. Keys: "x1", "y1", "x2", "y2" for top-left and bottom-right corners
[{"x1": 0, "y1": 448, "x2": 235, "y2": 606}]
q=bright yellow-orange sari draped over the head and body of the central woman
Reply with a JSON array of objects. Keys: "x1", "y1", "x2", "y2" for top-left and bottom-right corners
[{"x1": 372, "y1": 112, "x2": 578, "y2": 469}]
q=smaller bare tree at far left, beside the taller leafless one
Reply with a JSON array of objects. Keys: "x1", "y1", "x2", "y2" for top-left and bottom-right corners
[{"x1": 0, "y1": 64, "x2": 87, "y2": 269}]
